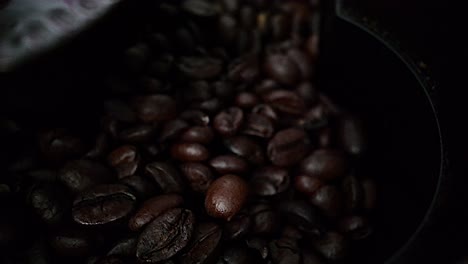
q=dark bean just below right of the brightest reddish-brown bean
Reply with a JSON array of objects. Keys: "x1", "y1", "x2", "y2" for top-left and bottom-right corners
[{"x1": 249, "y1": 203, "x2": 280, "y2": 235}]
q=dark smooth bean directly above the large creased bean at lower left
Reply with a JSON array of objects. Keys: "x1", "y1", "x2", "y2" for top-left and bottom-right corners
[{"x1": 58, "y1": 160, "x2": 114, "y2": 193}]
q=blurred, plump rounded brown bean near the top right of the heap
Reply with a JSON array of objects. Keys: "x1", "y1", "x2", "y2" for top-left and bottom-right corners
[{"x1": 264, "y1": 54, "x2": 301, "y2": 86}]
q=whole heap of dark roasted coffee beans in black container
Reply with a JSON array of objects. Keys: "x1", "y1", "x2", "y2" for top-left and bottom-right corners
[{"x1": 0, "y1": 0, "x2": 376, "y2": 264}]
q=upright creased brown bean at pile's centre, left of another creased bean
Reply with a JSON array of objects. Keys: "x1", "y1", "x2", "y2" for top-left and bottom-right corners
[{"x1": 213, "y1": 107, "x2": 244, "y2": 136}]
